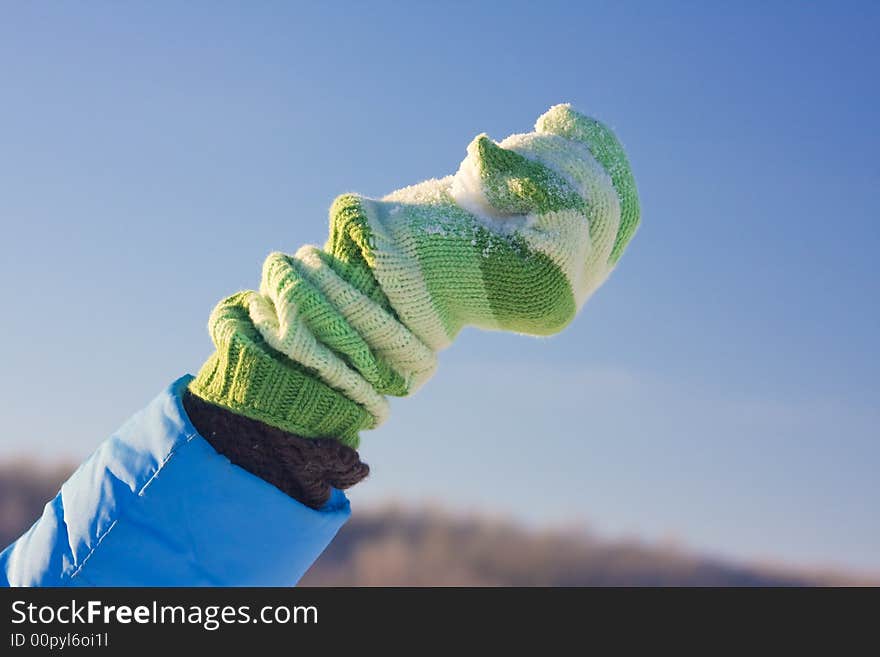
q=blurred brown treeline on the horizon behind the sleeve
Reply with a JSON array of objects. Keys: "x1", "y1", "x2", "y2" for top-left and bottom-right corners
[{"x1": 0, "y1": 463, "x2": 868, "y2": 586}]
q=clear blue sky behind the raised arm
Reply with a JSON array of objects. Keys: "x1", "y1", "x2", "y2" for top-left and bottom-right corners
[{"x1": 0, "y1": 1, "x2": 880, "y2": 571}]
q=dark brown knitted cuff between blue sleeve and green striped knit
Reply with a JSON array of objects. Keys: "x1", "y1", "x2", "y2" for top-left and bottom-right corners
[{"x1": 183, "y1": 390, "x2": 370, "y2": 509}]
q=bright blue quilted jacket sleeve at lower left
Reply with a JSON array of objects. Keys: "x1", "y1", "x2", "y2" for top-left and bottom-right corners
[{"x1": 0, "y1": 376, "x2": 350, "y2": 586}]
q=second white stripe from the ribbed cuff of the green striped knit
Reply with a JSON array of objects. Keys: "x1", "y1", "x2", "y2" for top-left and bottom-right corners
[{"x1": 294, "y1": 245, "x2": 437, "y2": 392}]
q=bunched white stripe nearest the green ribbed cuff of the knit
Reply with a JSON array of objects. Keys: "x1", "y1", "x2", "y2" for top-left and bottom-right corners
[{"x1": 248, "y1": 282, "x2": 390, "y2": 428}]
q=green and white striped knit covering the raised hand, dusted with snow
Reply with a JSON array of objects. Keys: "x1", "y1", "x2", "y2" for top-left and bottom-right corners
[{"x1": 190, "y1": 105, "x2": 639, "y2": 447}]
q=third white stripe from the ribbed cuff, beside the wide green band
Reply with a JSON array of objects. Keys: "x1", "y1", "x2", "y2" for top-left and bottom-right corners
[{"x1": 361, "y1": 199, "x2": 452, "y2": 351}]
